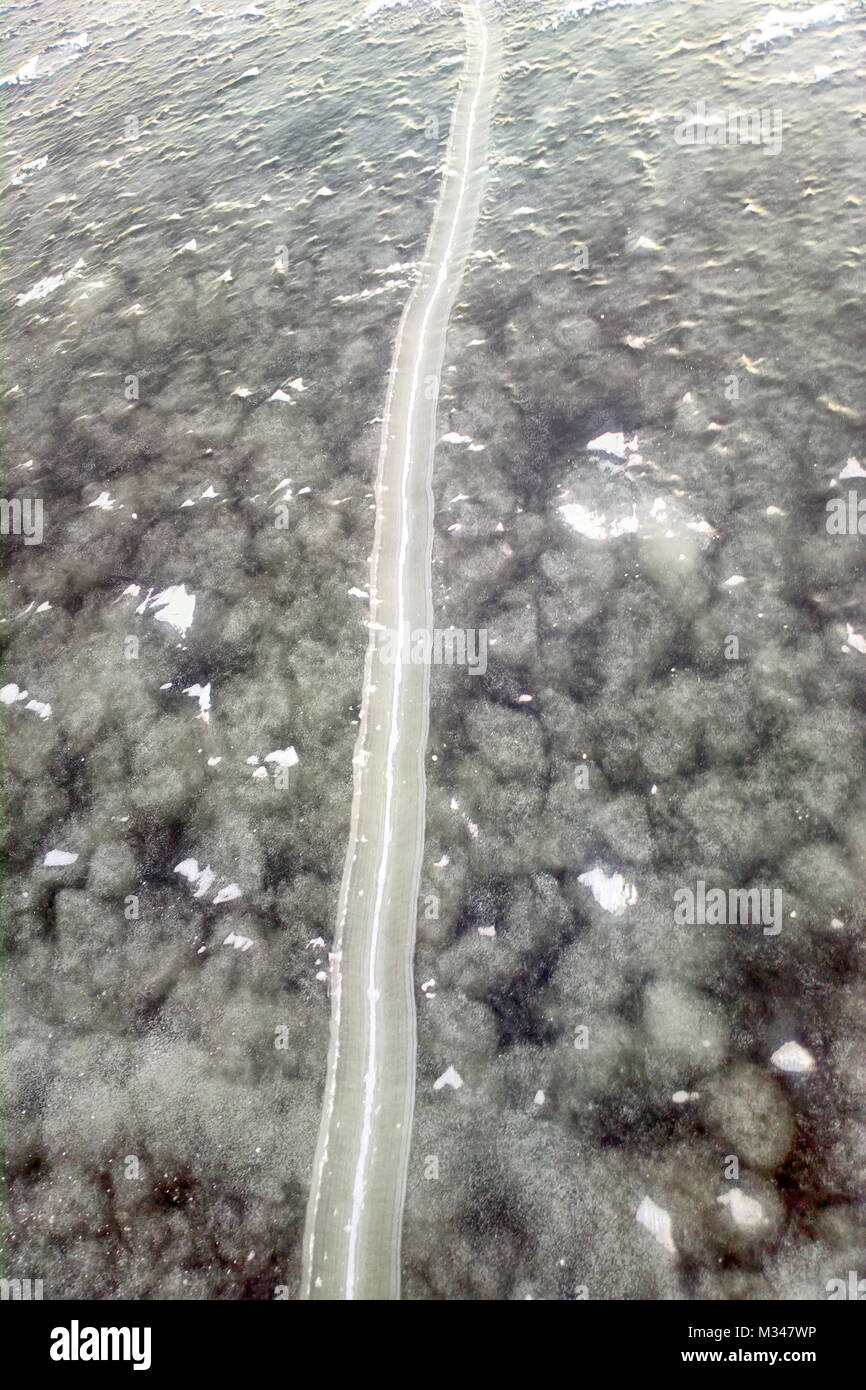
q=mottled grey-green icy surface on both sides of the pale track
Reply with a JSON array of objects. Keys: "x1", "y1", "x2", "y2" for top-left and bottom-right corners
[{"x1": 0, "y1": 0, "x2": 866, "y2": 1300}]
